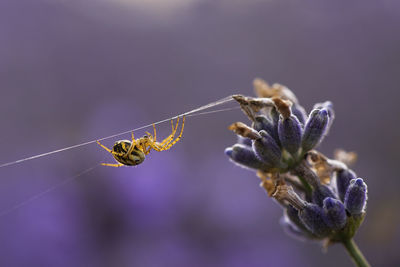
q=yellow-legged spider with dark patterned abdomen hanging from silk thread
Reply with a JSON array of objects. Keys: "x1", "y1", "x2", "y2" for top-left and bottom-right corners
[{"x1": 96, "y1": 116, "x2": 185, "y2": 167}]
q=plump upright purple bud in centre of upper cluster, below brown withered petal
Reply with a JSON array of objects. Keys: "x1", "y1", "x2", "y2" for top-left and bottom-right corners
[{"x1": 278, "y1": 115, "x2": 302, "y2": 155}]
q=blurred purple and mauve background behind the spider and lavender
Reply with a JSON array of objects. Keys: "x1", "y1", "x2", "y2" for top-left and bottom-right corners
[{"x1": 0, "y1": 0, "x2": 400, "y2": 267}]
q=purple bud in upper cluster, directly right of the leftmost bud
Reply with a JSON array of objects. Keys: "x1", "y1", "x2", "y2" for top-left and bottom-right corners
[{"x1": 253, "y1": 130, "x2": 282, "y2": 167}]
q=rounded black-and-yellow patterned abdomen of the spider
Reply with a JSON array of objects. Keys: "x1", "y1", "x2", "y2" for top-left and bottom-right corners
[{"x1": 113, "y1": 140, "x2": 145, "y2": 166}]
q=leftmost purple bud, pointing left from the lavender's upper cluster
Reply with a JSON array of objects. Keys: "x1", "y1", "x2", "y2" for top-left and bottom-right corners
[{"x1": 225, "y1": 144, "x2": 269, "y2": 170}]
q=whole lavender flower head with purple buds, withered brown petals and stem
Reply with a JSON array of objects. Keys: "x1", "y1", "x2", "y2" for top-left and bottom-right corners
[{"x1": 225, "y1": 79, "x2": 369, "y2": 267}]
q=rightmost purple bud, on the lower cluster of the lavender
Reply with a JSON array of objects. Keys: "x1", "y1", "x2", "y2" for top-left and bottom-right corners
[{"x1": 344, "y1": 178, "x2": 368, "y2": 215}]
